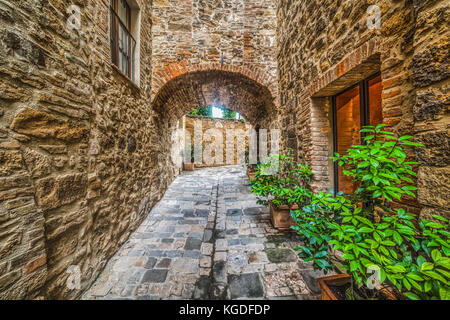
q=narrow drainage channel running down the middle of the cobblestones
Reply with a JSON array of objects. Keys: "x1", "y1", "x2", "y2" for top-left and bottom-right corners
[{"x1": 193, "y1": 176, "x2": 228, "y2": 300}]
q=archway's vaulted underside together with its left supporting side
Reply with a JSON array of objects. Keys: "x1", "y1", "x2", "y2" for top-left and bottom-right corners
[{"x1": 152, "y1": 69, "x2": 277, "y2": 172}]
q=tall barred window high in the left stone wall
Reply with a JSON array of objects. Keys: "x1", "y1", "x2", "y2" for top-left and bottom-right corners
[{"x1": 111, "y1": 0, "x2": 139, "y2": 84}]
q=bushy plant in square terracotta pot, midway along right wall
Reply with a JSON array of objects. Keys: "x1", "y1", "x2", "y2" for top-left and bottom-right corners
[{"x1": 250, "y1": 150, "x2": 312, "y2": 231}]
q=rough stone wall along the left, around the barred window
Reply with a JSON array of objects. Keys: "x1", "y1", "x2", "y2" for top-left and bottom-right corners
[{"x1": 0, "y1": 0, "x2": 167, "y2": 299}]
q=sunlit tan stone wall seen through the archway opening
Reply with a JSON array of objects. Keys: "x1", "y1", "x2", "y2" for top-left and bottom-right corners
[{"x1": 185, "y1": 116, "x2": 251, "y2": 168}]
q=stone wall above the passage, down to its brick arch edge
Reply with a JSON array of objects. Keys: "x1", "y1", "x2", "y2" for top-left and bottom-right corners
[{"x1": 152, "y1": 0, "x2": 277, "y2": 102}]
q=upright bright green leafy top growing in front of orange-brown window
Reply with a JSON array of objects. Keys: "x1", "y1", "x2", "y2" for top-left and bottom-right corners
[{"x1": 331, "y1": 124, "x2": 421, "y2": 217}]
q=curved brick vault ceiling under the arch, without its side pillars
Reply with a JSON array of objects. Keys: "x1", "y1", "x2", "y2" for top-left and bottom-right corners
[{"x1": 153, "y1": 70, "x2": 275, "y2": 123}]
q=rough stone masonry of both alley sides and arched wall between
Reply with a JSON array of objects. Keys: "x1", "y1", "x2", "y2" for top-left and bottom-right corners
[{"x1": 0, "y1": 0, "x2": 450, "y2": 299}]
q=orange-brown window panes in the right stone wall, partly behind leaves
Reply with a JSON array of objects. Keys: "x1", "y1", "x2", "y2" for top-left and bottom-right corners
[{"x1": 333, "y1": 74, "x2": 383, "y2": 193}]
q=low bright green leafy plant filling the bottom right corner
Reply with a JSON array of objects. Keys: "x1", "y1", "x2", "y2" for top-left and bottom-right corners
[{"x1": 329, "y1": 208, "x2": 450, "y2": 299}]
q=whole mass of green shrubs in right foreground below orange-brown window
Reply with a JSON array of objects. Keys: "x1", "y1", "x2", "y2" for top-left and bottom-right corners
[{"x1": 292, "y1": 125, "x2": 450, "y2": 300}]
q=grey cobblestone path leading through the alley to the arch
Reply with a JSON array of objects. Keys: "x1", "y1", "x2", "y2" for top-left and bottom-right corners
[{"x1": 83, "y1": 166, "x2": 319, "y2": 299}]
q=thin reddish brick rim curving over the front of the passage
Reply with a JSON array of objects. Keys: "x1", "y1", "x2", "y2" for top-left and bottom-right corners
[{"x1": 151, "y1": 60, "x2": 278, "y2": 105}]
